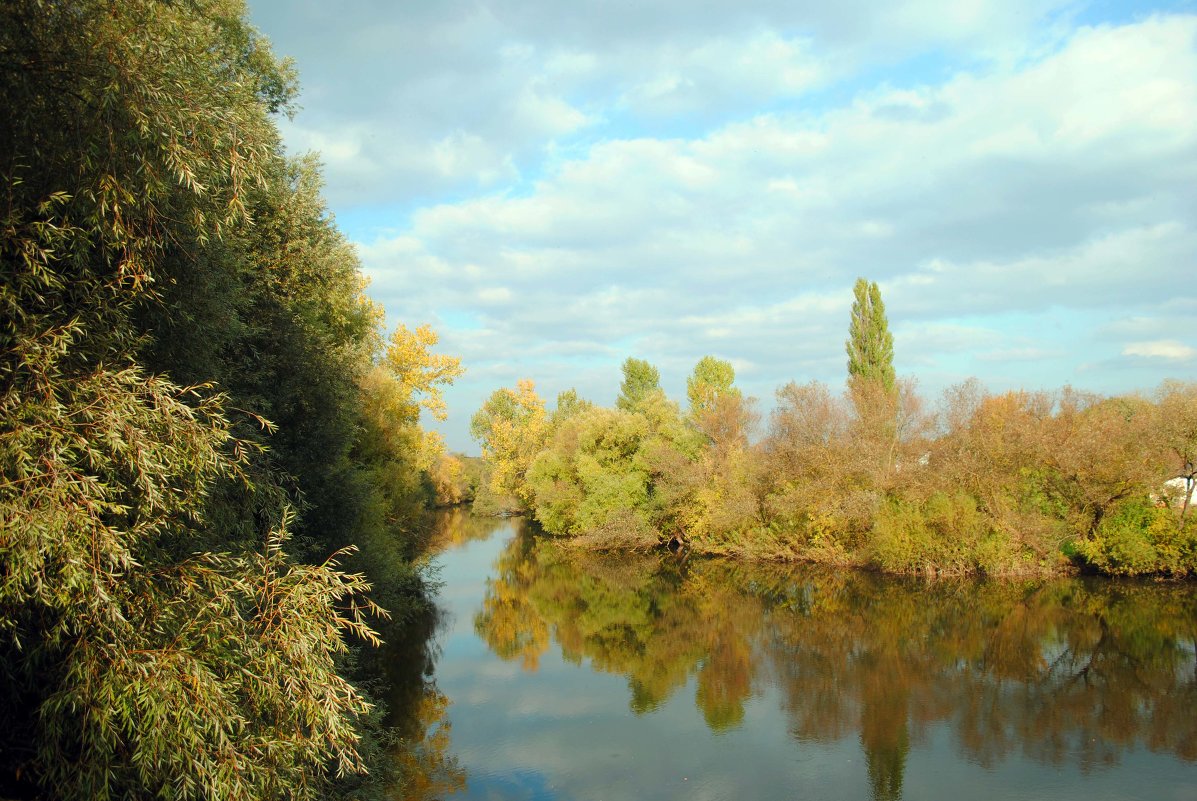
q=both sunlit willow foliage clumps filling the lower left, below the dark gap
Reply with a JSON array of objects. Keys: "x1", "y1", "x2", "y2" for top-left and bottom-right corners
[{"x1": 0, "y1": 334, "x2": 383, "y2": 799}]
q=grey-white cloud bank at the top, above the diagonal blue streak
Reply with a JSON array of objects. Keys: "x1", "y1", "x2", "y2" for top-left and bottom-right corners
[{"x1": 250, "y1": 0, "x2": 1069, "y2": 206}]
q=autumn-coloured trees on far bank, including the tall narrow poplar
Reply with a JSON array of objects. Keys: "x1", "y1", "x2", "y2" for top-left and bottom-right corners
[{"x1": 472, "y1": 279, "x2": 1197, "y2": 576}]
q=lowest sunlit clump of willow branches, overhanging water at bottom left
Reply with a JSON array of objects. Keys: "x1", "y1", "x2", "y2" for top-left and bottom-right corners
[{"x1": 38, "y1": 519, "x2": 377, "y2": 799}]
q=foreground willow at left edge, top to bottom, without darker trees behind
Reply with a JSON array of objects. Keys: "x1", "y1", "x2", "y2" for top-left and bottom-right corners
[{"x1": 0, "y1": 0, "x2": 383, "y2": 799}]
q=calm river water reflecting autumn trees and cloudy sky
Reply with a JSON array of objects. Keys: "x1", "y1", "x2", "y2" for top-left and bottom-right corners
[{"x1": 395, "y1": 515, "x2": 1197, "y2": 801}]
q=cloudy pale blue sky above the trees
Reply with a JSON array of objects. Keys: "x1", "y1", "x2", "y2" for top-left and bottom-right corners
[{"x1": 249, "y1": 0, "x2": 1197, "y2": 454}]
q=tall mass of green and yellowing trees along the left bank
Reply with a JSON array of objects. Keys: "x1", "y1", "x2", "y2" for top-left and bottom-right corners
[{"x1": 0, "y1": 0, "x2": 461, "y2": 799}]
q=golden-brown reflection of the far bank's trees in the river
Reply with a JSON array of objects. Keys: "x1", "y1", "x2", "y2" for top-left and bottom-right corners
[{"x1": 474, "y1": 536, "x2": 1197, "y2": 800}]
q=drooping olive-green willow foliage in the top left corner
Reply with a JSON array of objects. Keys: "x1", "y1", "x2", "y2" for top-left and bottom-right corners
[{"x1": 0, "y1": 0, "x2": 292, "y2": 354}]
